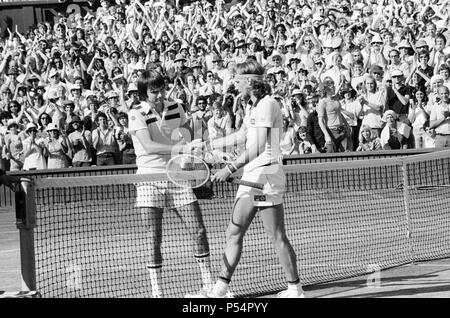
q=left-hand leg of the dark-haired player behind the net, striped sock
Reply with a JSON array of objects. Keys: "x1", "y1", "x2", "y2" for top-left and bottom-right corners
[{"x1": 141, "y1": 207, "x2": 164, "y2": 298}]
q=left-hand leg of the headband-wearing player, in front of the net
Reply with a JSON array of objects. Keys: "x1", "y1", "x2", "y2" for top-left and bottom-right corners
[{"x1": 209, "y1": 196, "x2": 257, "y2": 297}]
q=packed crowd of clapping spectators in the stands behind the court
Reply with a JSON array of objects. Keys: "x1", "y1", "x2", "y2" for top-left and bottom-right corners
[{"x1": 0, "y1": 0, "x2": 450, "y2": 171}]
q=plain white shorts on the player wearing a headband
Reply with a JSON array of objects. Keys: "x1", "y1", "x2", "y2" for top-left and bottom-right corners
[{"x1": 236, "y1": 164, "x2": 286, "y2": 207}]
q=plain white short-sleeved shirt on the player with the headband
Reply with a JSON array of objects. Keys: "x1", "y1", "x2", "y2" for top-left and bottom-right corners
[{"x1": 244, "y1": 96, "x2": 283, "y2": 172}]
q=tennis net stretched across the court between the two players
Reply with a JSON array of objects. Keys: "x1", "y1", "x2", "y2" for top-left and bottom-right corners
[{"x1": 16, "y1": 151, "x2": 450, "y2": 297}]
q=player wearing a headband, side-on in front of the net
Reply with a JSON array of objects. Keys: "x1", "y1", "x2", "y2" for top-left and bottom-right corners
[{"x1": 192, "y1": 60, "x2": 304, "y2": 298}]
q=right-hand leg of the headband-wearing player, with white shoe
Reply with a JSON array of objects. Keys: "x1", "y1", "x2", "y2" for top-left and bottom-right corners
[{"x1": 260, "y1": 204, "x2": 303, "y2": 297}]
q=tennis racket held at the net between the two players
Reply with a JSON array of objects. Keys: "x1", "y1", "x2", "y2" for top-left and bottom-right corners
[{"x1": 166, "y1": 154, "x2": 264, "y2": 190}]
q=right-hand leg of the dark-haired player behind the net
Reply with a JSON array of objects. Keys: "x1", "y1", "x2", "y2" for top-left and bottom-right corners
[{"x1": 177, "y1": 201, "x2": 213, "y2": 297}]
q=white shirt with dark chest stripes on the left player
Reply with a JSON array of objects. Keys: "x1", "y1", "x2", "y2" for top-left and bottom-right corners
[{"x1": 128, "y1": 101, "x2": 186, "y2": 173}]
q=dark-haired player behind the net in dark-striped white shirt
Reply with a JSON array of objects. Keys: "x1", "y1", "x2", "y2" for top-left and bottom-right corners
[{"x1": 128, "y1": 69, "x2": 213, "y2": 297}]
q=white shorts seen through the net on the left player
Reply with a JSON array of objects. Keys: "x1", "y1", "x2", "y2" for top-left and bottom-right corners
[{"x1": 136, "y1": 168, "x2": 197, "y2": 209}]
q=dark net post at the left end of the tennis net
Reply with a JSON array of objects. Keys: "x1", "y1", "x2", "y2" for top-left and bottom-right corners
[{"x1": 15, "y1": 181, "x2": 36, "y2": 291}]
